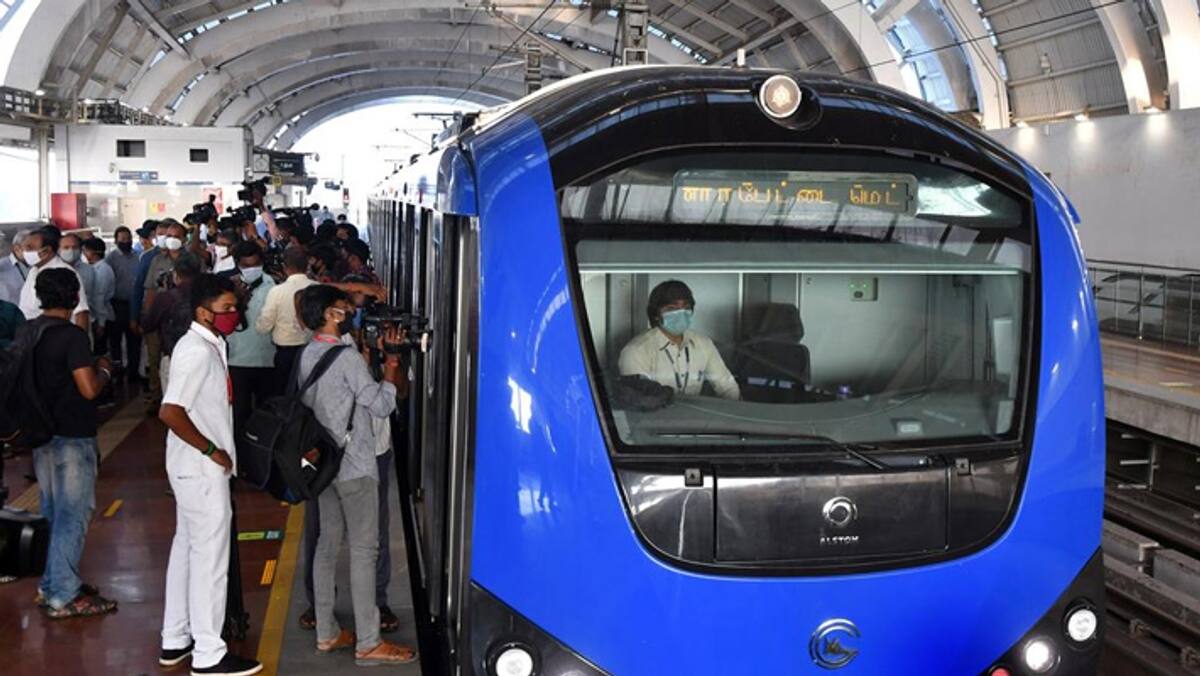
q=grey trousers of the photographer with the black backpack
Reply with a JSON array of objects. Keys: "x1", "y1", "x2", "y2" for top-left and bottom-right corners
[{"x1": 313, "y1": 477, "x2": 379, "y2": 652}]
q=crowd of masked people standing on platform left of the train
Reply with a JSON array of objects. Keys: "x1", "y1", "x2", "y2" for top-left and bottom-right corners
[{"x1": 0, "y1": 204, "x2": 415, "y2": 675}]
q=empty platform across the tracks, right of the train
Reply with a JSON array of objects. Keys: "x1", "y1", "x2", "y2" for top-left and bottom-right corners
[{"x1": 1102, "y1": 334, "x2": 1200, "y2": 447}]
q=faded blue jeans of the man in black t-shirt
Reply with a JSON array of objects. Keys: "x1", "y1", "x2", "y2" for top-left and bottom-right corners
[{"x1": 34, "y1": 437, "x2": 98, "y2": 609}]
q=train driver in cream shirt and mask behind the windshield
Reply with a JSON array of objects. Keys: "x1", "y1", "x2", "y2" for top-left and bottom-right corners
[{"x1": 618, "y1": 280, "x2": 742, "y2": 399}]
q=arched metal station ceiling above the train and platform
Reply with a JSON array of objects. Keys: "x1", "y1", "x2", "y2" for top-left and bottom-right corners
[{"x1": 0, "y1": 0, "x2": 1200, "y2": 148}]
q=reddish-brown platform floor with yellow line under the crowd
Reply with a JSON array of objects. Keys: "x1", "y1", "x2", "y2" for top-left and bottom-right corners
[{"x1": 0, "y1": 393, "x2": 420, "y2": 676}]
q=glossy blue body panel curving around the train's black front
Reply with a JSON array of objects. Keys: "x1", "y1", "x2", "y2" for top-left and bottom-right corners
[{"x1": 374, "y1": 64, "x2": 1104, "y2": 676}]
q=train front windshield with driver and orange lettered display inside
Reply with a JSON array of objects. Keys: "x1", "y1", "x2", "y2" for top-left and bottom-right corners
[{"x1": 560, "y1": 151, "x2": 1032, "y2": 453}]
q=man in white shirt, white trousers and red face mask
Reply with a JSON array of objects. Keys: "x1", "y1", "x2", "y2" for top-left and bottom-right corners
[{"x1": 158, "y1": 275, "x2": 263, "y2": 676}]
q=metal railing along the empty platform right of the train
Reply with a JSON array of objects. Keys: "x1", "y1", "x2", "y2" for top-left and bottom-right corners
[{"x1": 1087, "y1": 261, "x2": 1200, "y2": 348}]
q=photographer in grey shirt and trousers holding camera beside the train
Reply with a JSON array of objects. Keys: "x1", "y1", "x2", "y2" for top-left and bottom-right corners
[{"x1": 296, "y1": 285, "x2": 416, "y2": 666}]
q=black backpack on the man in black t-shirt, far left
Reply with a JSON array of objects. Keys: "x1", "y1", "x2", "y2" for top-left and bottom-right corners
[{"x1": 0, "y1": 316, "x2": 72, "y2": 448}]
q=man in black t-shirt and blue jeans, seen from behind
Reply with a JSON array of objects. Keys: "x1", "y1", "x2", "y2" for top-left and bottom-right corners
[{"x1": 20, "y1": 269, "x2": 116, "y2": 620}]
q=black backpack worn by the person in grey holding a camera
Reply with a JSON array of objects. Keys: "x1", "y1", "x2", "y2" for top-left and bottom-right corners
[{"x1": 238, "y1": 345, "x2": 354, "y2": 504}]
